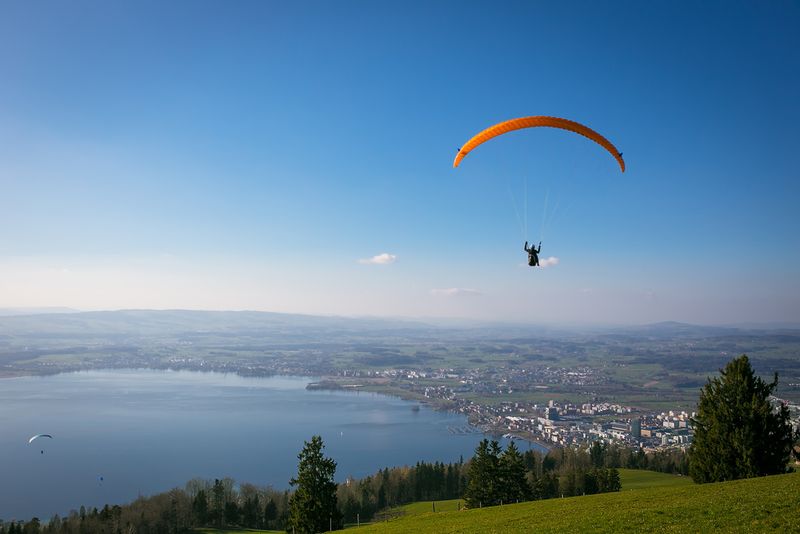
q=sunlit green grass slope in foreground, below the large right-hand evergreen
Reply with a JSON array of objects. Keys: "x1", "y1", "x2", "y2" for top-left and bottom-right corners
[{"x1": 360, "y1": 473, "x2": 800, "y2": 534}]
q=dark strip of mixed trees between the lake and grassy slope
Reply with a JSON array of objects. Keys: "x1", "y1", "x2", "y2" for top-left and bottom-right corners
[{"x1": 0, "y1": 442, "x2": 618, "y2": 534}]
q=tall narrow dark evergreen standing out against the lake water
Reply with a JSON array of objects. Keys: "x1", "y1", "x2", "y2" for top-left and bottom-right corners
[{"x1": 286, "y1": 436, "x2": 342, "y2": 534}]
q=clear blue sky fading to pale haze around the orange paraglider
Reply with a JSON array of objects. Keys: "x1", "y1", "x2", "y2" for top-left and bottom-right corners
[{"x1": 0, "y1": 1, "x2": 800, "y2": 324}]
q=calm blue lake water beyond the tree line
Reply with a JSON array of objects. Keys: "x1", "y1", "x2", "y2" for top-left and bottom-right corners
[{"x1": 0, "y1": 370, "x2": 544, "y2": 520}]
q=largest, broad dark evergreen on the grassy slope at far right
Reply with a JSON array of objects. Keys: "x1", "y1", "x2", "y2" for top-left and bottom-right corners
[{"x1": 689, "y1": 355, "x2": 792, "y2": 483}]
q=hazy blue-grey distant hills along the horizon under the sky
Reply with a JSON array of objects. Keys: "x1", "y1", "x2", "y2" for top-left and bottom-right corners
[{"x1": 0, "y1": 308, "x2": 800, "y2": 341}]
